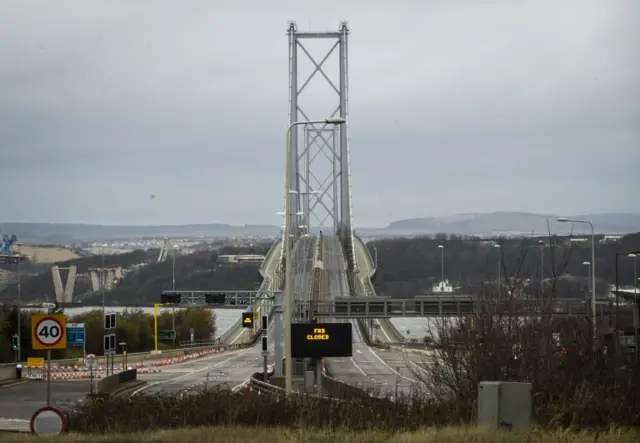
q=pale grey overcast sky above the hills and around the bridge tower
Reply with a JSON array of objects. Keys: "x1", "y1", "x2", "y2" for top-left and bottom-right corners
[{"x1": 0, "y1": 0, "x2": 640, "y2": 227}]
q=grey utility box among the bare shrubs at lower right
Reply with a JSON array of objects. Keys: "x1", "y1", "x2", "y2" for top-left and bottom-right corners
[{"x1": 478, "y1": 381, "x2": 531, "y2": 429}]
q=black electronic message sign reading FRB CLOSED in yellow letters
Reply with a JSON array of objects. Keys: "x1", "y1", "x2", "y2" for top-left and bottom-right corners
[{"x1": 291, "y1": 323, "x2": 352, "y2": 358}]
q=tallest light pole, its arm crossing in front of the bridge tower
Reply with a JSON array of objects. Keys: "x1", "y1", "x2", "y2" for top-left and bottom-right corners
[{"x1": 282, "y1": 117, "x2": 346, "y2": 394}]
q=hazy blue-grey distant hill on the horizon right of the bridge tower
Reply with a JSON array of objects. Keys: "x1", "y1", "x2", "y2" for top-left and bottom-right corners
[{"x1": 385, "y1": 212, "x2": 640, "y2": 235}]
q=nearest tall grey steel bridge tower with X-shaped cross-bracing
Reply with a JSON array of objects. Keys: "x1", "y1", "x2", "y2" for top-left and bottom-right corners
[{"x1": 285, "y1": 21, "x2": 356, "y2": 271}]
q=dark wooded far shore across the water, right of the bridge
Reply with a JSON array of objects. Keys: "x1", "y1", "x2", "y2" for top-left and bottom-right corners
[{"x1": 368, "y1": 233, "x2": 640, "y2": 298}]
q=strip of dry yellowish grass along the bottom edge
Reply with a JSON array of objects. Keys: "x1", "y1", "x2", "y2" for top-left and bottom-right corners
[{"x1": 1, "y1": 427, "x2": 640, "y2": 443}]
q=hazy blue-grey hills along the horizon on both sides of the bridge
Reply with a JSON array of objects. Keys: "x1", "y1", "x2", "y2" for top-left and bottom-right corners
[{"x1": 0, "y1": 212, "x2": 640, "y2": 245}]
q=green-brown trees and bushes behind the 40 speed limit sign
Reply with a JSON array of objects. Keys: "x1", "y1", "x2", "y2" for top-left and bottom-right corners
[{"x1": 0, "y1": 307, "x2": 216, "y2": 362}]
